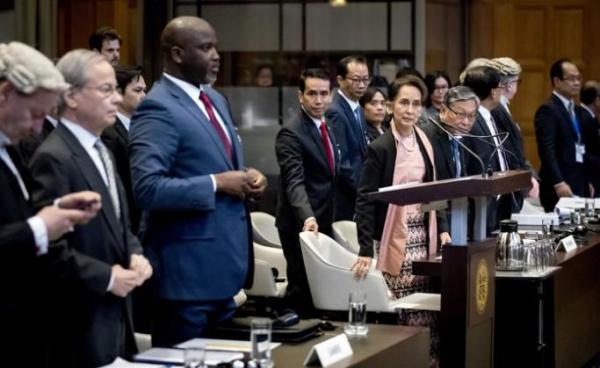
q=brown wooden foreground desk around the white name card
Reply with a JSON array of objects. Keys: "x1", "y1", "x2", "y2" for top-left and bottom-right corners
[{"x1": 273, "y1": 325, "x2": 429, "y2": 368}]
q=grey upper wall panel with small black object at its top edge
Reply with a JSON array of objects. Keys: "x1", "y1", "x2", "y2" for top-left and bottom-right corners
[{"x1": 306, "y1": 2, "x2": 390, "y2": 51}]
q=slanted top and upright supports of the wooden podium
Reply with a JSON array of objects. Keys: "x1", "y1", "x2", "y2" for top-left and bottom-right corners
[{"x1": 369, "y1": 170, "x2": 531, "y2": 245}]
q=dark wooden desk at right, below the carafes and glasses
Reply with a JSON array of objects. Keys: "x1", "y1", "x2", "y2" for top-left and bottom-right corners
[{"x1": 413, "y1": 233, "x2": 600, "y2": 367}]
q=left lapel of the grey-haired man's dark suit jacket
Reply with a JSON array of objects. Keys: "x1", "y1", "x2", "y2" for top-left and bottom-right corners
[{"x1": 57, "y1": 124, "x2": 123, "y2": 244}]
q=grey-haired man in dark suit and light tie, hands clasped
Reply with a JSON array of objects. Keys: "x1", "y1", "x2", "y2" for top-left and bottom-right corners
[{"x1": 31, "y1": 49, "x2": 152, "y2": 367}]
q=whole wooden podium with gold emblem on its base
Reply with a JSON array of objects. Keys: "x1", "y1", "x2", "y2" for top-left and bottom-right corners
[{"x1": 369, "y1": 171, "x2": 531, "y2": 367}]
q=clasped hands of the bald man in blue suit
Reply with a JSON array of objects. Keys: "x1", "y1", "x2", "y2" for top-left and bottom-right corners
[{"x1": 214, "y1": 168, "x2": 267, "y2": 199}]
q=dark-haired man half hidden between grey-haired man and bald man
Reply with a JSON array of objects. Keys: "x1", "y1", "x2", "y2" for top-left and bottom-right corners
[{"x1": 102, "y1": 65, "x2": 146, "y2": 234}]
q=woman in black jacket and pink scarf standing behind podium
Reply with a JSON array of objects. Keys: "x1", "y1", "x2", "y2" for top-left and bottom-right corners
[{"x1": 352, "y1": 76, "x2": 450, "y2": 365}]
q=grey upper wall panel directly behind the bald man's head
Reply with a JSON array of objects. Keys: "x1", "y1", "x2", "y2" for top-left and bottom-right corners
[{"x1": 202, "y1": 4, "x2": 279, "y2": 51}]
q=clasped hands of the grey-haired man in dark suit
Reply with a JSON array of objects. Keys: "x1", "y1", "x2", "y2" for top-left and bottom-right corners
[{"x1": 109, "y1": 254, "x2": 152, "y2": 298}]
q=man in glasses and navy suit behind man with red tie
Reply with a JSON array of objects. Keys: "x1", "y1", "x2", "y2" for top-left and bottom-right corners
[{"x1": 325, "y1": 56, "x2": 371, "y2": 221}]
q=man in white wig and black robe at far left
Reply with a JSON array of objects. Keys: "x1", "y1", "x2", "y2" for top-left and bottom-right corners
[{"x1": 0, "y1": 42, "x2": 100, "y2": 366}]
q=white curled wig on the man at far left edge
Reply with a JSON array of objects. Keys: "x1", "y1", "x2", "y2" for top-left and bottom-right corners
[{"x1": 0, "y1": 42, "x2": 69, "y2": 94}]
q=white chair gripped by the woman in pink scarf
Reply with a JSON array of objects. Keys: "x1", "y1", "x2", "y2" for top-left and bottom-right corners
[{"x1": 300, "y1": 231, "x2": 440, "y2": 312}]
